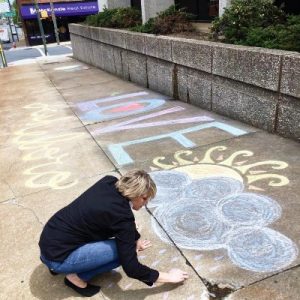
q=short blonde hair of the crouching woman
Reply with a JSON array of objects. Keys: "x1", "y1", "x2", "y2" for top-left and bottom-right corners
[{"x1": 116, "y1": 170, "x2": 156, "y2": 200}]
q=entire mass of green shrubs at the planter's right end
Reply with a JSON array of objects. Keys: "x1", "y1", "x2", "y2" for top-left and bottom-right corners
[{"x1": 212, "y1": 0, "x2": 300, "y2": 52}]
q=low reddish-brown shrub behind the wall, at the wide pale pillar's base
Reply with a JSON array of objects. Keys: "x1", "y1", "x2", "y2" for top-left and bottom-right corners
[{"x1": 131, "y1": 5, "x2": 194, "y2": 34}]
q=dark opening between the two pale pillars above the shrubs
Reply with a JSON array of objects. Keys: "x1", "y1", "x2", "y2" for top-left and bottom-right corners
[{"x1": 175, "y1": 0, "x2": 219, "y2": 21}]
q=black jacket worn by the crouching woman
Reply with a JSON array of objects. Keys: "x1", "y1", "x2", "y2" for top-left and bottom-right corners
[{"x1": 39, "y1": 176, "x2": 159, "y2": 285}]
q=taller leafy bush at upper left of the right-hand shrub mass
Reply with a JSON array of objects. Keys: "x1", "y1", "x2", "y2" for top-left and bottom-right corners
[{"x1": 212, "y1": 0, "x2": 286, "y2": 44}]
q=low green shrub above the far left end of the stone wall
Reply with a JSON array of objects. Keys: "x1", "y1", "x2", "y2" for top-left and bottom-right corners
[{"x1": 85, "y1": 7, "x2": 142, "y2": 28}]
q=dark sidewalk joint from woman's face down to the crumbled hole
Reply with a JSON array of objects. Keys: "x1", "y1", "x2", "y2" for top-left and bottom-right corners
[{"x1": 146, "y1": 207, "x2": 235, "y2": 300}]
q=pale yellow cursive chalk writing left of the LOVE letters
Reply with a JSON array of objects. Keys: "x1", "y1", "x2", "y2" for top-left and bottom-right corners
[{"x1": 14, "y1": 103, "x2": 83, "y2": 189}]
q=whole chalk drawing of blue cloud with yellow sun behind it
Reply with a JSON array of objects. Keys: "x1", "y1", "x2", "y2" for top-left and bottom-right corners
[{"x1": 148, "y1": 146, "x2": 298, "y2": 272}]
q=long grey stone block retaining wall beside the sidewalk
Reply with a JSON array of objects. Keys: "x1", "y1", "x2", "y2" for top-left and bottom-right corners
[{"x1": 69, "y1": 24, "x2": 300, "y2": 140}]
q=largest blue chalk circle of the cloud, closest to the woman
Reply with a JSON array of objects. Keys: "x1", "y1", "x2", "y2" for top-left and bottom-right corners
[{"x1": 150, "y1": 198, "x2": 231, "y2": 250}]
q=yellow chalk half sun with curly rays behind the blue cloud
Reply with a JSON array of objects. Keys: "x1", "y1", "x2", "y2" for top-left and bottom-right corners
[{"x1": 151, "y1": 146, "x2": 289, "y2": 191}]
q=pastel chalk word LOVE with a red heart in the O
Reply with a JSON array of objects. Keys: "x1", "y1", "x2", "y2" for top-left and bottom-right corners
[{"x1": 75, "y1": 91, "x2": 248, "y2": 166}]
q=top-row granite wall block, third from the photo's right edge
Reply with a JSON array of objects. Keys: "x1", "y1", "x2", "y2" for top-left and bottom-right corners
[{"x1": 171, "y1": 38, "x2": 212, "y2": 73}]
